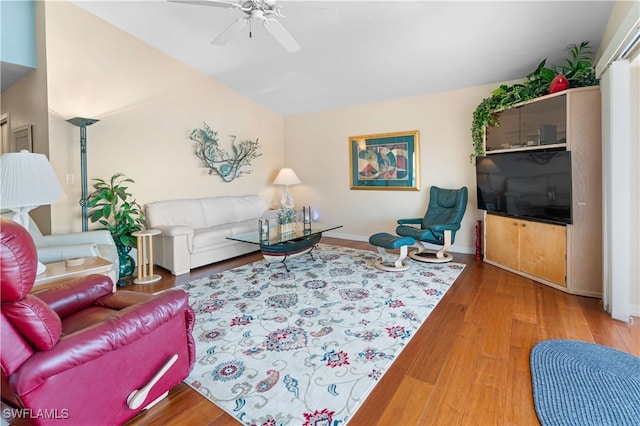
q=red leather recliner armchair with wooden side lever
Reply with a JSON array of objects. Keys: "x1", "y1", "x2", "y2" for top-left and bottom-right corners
[{"x1": 0, "y1": 219, "x2": 195, "y2": 425}]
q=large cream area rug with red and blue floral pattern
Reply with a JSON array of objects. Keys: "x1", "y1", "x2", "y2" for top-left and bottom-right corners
[{"x1": 182, "y1": 244, "x2": 464, "y2": 426}]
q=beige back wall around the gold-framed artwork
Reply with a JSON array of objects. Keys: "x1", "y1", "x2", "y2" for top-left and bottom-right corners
[{"x1": 285, "y1": 84, "x2": 498, "y2": 253}]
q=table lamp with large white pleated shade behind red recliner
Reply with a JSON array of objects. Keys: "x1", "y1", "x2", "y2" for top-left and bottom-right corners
[{"x1": 0, "y1": 150, "x2": 63, "y2": 274}]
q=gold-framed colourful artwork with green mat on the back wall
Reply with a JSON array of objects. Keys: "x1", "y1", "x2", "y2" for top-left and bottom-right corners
[{"x1": 349, "y1": 130, "x2": 420, "y2": 191}]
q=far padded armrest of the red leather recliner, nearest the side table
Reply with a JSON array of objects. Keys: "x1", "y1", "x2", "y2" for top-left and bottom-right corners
[{"x1": 34, "y1": 274, "x2": 113, "y2": 319}]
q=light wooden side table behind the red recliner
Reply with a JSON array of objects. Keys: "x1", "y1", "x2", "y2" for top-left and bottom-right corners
[{"x1": 31, "y1": 256, "x2": 116, "y2": 292}]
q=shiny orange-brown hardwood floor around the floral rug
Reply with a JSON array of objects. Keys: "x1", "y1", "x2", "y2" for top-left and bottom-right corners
[{"x1": 125, "y1": 238, "x2": 640, "y2": 426}]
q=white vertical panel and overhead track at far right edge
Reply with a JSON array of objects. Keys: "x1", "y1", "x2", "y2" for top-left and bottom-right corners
[{"x1": 596, "y1": 3, "x2": 640, "y2": 322}]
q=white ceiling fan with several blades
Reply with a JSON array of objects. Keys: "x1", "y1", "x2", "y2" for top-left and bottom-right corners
[{"x1": 167, "y1": 0, "x2": 301, "y2": 52}]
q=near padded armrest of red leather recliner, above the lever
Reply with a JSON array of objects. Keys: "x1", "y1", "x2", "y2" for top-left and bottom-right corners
[{"x1": 9, "y1": 289, "x2": 191, "y2": 395}]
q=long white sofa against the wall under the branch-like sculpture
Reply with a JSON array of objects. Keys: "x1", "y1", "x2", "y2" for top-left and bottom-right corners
[{"x1": 146, "y1": 195, "x2": 268, "y2": 275}]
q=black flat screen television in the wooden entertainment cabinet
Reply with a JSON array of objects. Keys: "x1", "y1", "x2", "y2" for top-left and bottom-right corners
[{"x1": 476, "y1": 150, "x2": 572, "y2": 224}]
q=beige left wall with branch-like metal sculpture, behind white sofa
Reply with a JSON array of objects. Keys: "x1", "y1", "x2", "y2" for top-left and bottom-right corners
[{"x1": 46, "y1": 1, "x2": 284, "y2": 233}]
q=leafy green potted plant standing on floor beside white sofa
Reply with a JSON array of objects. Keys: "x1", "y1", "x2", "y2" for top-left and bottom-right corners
[{"x1": 88, "y1": 173, "x2": 147, "y2": 278}]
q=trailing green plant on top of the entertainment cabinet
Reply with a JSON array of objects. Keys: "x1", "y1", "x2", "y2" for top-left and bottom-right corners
[{"x1": 470, "y1": 41, "x2": 599, "y2": 162}]
